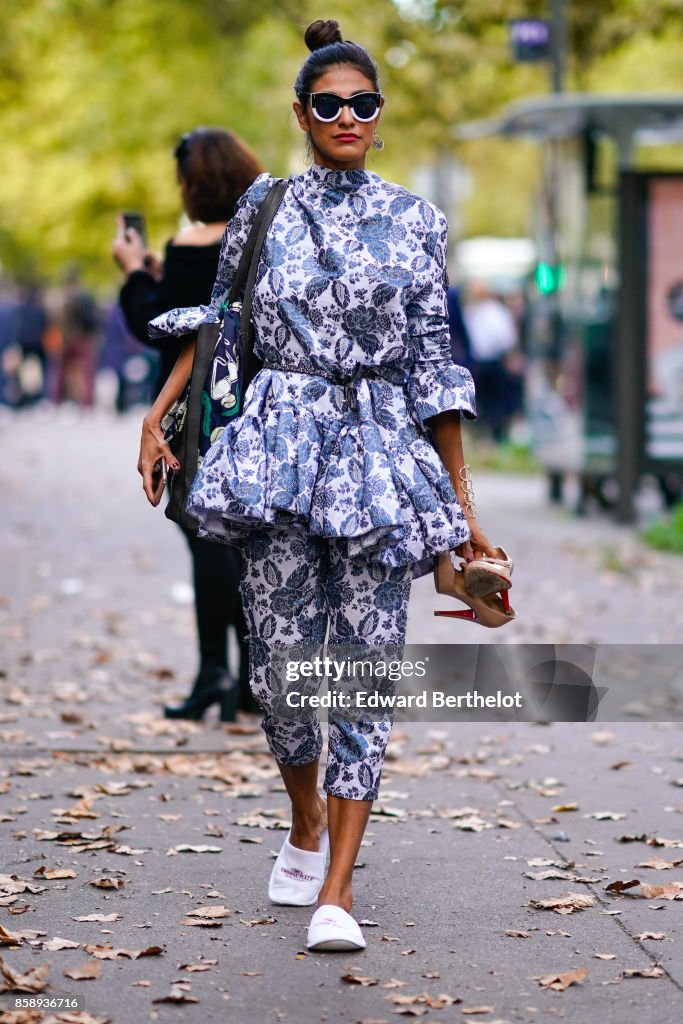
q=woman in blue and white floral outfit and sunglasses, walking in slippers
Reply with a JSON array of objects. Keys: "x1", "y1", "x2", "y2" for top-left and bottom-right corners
[{"x1": 139, "y1": 22, "x2": 495, "y2": 950}]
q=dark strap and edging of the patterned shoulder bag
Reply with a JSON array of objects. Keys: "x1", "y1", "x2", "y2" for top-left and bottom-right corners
[{"x1": 175, "y1": 178, "x2": 289, "y2": 530}]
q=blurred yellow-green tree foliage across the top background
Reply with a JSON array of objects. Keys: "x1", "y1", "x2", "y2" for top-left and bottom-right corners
[{"x1": 0, "y1": 0, "x2": 683, "y2": 287}]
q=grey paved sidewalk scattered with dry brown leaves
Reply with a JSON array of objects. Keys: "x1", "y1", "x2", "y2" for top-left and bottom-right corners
[{"x1": 0, "y1": 413, "x2": 683, "y2": 1024}]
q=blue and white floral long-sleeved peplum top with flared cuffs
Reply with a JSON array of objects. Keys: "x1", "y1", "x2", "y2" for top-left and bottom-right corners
[{"x1": 150, "y1": 164, "x2": 475, "y2": 795}]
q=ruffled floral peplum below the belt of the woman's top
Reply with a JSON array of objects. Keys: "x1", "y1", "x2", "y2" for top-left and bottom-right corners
[{"x1": 187, "y1": 369, "x2": 469, "y2": 574}]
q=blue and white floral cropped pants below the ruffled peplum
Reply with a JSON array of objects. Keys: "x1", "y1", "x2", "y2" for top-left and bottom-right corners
[{"x1": 241, "y1": 527, "x2": 411, "y2": 800}]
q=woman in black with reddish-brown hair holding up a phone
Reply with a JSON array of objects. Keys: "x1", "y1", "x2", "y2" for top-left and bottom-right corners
[{"x1": 113, "y1": 128, "x2": 262, "y2": 721}]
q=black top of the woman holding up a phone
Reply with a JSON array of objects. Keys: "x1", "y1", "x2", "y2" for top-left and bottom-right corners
[{"x1": 119, "y1": 241, "x2": 220, "y2": 394}]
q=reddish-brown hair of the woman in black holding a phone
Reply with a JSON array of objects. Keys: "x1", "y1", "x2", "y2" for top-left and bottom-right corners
[{"x1": 173, "y1": 128, "x2": 263, "y2": 223}]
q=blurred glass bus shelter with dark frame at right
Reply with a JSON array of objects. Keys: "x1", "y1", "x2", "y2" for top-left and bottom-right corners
[{"x1": 456, "y1": 93, "x2": 683, "y2": 522}]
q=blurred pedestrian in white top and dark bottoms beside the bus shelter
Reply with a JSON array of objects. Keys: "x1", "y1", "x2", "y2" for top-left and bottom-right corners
[{"x1": 463, "y1": 281, "x2": 517, "y2": 442}]
